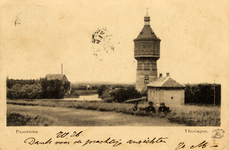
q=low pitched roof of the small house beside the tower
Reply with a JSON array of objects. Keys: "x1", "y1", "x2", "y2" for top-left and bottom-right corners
[{"x1": 147, "y1": 76, "x2": 185, "y2": 88}]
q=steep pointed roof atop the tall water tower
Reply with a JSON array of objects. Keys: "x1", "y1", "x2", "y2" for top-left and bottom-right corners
[{"x1": 134, "y1": 25, "x2": 160, "y2": 41}]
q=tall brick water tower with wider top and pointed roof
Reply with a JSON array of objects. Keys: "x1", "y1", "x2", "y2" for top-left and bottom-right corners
[{"x1": 134, "y1": 14, "x2": 161, "y2": 91}]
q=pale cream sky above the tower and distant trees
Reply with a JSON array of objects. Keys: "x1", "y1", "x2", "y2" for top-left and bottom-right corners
[{"x1": 0, "y1": 0, "x2": 229, "y2": 84}]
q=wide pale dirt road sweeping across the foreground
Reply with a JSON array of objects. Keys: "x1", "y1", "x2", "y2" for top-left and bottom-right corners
[{"x1": 7, "y1": 104, "x2": 184, "y2": 126}]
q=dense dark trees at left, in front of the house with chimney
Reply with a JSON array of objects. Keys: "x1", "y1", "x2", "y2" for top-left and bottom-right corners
[{"x1": 6, "y1": 78, "x2": 70, "y2": 99}]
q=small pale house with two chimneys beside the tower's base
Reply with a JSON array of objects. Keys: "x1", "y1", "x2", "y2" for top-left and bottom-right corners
[{"x1": 147, "y1": 73, "x2": 185, "y2": 106}]
